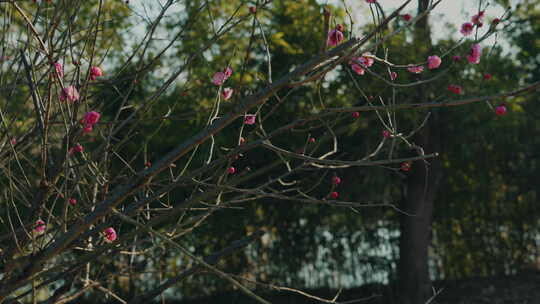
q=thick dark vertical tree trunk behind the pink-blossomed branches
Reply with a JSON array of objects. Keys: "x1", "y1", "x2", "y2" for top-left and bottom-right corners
[{"x1": 398, "y1": 0, "x2": 442, "y2": 304}]
